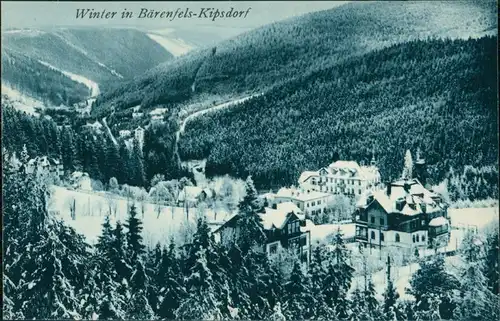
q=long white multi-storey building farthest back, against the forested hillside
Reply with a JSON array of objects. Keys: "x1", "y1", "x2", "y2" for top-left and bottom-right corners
[{"x1": 299, "y1": 160, "x2": 381, "y2": 197}]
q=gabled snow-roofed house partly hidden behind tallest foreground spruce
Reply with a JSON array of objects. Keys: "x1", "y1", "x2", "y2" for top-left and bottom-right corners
[{"x1": 214, "y1": 202, "x2": 312, "y2": 264}]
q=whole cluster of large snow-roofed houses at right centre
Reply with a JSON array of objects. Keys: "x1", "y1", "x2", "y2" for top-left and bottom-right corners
[{"x1": 215, "y1": 158, "x2": 450, "y2": 262}]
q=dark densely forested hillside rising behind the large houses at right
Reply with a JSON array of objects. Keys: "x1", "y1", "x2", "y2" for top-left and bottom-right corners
[{"x1": 180, "y1": 37, "x2": 498, "y2": 192}]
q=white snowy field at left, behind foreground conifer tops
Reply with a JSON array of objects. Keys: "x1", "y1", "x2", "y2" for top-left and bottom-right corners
[{"x1": 49, "y1": 186, "x2": 233, "y2": 246}]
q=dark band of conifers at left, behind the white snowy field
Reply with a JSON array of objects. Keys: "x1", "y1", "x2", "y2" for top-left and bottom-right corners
[{"x1": 2, "y1": 105, "x2": 191, "y2": 187}]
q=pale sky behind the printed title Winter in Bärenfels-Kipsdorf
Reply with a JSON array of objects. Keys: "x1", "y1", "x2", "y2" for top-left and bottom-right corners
[{"x1": 1, "y1": 1, "x2": 347, "y2": 30}]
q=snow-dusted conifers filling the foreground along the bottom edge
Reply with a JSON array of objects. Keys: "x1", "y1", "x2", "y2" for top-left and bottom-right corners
[{"x1": 3, "y1": 164, "x2": 498, "y2": 321}]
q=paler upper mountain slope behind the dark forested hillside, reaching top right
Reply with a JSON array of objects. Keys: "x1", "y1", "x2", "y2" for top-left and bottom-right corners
[{"x1": 91, "y1": 1, "x2": 497, "y2": 112}]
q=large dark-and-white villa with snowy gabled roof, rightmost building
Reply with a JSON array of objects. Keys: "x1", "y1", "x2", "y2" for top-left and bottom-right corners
[{"x1": 355, "y1": 179, "x2": 450, "y2": 248}]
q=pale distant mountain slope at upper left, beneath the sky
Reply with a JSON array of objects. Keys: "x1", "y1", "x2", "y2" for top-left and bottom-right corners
[{"x1": 2, "y1": 29, "x2": 173, "y2": 104}]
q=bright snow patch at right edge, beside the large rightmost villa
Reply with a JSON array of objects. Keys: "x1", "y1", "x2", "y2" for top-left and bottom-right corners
[{"x1": 448, "y1": 207, "x2": 499, "y2": 229}]
